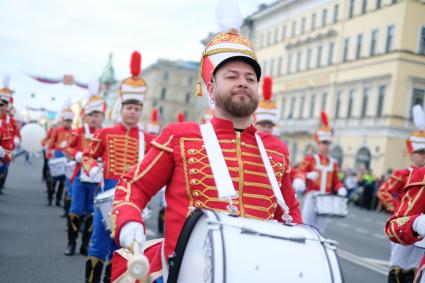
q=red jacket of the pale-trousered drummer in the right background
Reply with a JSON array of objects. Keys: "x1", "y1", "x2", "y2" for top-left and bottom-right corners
[{"x1": 296, "y1": 154, "x2": 343, "y2": 193}]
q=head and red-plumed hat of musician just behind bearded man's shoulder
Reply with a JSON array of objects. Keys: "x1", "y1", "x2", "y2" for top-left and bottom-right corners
[{"x1": 255, "y1": 76, "x2": 277, "y2": 134}]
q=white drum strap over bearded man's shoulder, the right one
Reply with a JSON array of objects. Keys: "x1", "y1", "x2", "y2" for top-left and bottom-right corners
[{"x1": 255, "y1": 134, "x2": 292, "y2": 223}]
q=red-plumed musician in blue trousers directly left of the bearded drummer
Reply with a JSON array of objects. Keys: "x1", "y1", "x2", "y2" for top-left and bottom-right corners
[{"x1": 82, "y1": 51, "x2": 153, "y2": 283}]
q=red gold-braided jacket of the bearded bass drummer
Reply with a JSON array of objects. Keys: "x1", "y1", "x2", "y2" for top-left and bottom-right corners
[{"x1": 111, "y1": 118, "x2": 302, "y2": 264}]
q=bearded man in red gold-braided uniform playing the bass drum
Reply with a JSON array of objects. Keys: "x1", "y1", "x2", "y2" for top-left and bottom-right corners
[{"x1": 111, "y1": 17, "x2": 302, "y2": 282}]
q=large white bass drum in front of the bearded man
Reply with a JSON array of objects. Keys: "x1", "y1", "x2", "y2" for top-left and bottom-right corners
[{"x1": 167, "y1": 210, "x2": 343, "y2": 283}]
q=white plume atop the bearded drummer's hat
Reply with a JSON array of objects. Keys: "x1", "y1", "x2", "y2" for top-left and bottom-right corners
[{"x1": 216, "y1": 0, "x2": 243, "y2": 32}]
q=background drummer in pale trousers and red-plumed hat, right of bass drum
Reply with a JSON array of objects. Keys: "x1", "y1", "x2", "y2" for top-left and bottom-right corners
[{"x1": 293, "y1": 112, "x2": 347, "y2": 233}]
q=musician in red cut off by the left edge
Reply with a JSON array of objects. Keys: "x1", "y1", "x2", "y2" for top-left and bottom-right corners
[{"x1": 0, "y1": 76, "x2": 14, "y2": 194}]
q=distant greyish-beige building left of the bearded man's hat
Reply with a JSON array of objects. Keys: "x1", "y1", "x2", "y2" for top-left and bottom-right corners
[{"x1": 142, "y1": 60, "x2": 208, "y2": 127}]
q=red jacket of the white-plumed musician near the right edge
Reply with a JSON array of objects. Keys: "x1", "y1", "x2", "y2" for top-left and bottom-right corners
[{"x1": 377, "y1": 169, "x2": 415, "y2": 212}]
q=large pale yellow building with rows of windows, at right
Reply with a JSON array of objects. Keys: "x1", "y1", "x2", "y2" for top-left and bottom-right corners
[{"x1": 243, "y1": 0, "x2": 425, "y2": 175}]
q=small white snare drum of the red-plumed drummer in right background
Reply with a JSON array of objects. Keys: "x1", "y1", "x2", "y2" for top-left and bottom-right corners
[{"x1": 314, "y1": 194, "x2": 348, "y2": 217}]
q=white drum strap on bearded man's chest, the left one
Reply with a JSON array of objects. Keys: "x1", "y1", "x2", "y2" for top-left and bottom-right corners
[{"x1": 200, "y1": 123, "x2": 236, "y2": 199}]
